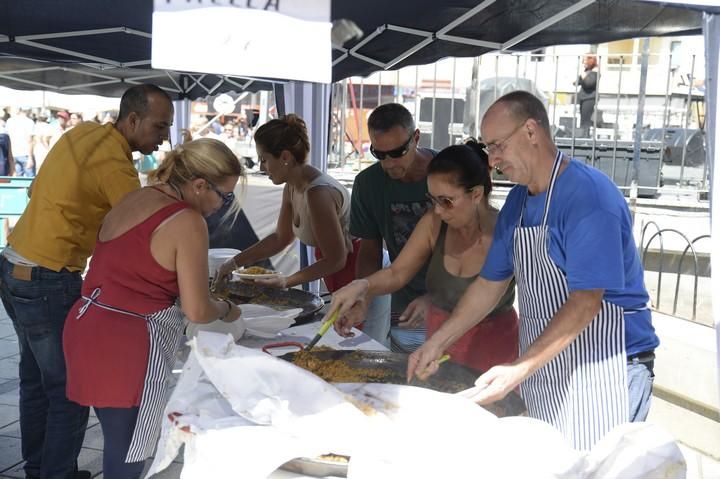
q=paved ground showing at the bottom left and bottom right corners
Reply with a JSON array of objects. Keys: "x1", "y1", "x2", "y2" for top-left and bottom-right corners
[{"x1": 0, "y1": 305, "x2": 720, "y2": 479}]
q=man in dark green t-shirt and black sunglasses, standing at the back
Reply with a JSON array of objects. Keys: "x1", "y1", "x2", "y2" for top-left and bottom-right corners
[{"x1": 350, "y1": 103, "x2": 436, "y2": 352}]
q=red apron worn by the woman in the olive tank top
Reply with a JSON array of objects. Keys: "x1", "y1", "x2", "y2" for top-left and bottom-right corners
[{"x1": 426, "y1": 304, "x2": 519, "y2": 372}]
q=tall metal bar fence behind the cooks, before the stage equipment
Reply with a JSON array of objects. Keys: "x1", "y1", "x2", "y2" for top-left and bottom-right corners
[{"x1": 330, "y1": 50, "x2": 708, "y2": 196}]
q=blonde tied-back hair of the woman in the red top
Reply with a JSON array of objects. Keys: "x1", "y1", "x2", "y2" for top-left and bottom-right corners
[{"x1": 148, "y1": 138, "x2": 245, "y2": 220}]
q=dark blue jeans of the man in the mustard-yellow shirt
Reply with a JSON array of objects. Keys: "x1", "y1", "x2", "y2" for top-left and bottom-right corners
[{"x1": 0, "y1": 256, "x2": 89, "y2": 479}]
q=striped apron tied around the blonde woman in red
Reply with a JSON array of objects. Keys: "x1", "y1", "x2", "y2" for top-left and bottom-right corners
[{"x1": 77, "y1": 288, "x2": 184, "y2": 462}]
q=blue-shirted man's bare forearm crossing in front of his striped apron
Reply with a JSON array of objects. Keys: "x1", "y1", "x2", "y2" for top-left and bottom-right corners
[{"x1": 515, "y1": 290, "x2": 604, "y2": 377}]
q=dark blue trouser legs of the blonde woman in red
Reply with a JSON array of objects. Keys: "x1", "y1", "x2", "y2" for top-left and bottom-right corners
[{"x1": 95, "y1": 407, "x2": 145, "y2": 479}]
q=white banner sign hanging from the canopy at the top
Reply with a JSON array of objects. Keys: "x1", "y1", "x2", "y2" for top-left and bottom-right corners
[{"x1": 152, "y1": 0, "x2": 332, "y2": 83}]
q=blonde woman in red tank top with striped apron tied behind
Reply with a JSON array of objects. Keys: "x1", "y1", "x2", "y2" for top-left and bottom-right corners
[{"x1": 63, "y1": 139, "x2": 244, "y2": 479}]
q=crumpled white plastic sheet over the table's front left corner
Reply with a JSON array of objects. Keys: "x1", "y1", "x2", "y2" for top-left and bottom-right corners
[{"x1": 147, "y1": 331, "x2": 367, "y2": 479}]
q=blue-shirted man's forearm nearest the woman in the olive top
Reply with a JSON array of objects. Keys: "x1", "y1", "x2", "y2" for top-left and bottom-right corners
[{"x1": 431, "y1": 277, "x2": 511, "y2": 350}]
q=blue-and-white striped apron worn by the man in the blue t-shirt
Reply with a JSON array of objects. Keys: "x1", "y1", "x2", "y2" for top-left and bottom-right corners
[{"x1": 513, "y1": 152, "x2": 628, "y2": 450}]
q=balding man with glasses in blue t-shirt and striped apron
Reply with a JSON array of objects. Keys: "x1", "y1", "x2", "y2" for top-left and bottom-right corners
[{"x1": 408, "y1": 91, "x2": 659, "y2": 450}]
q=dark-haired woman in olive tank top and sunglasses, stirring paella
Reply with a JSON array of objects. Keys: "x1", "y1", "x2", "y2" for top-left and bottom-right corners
[{"x1": 328, "y1": 141, "x2": 518, "y2": 371}]
